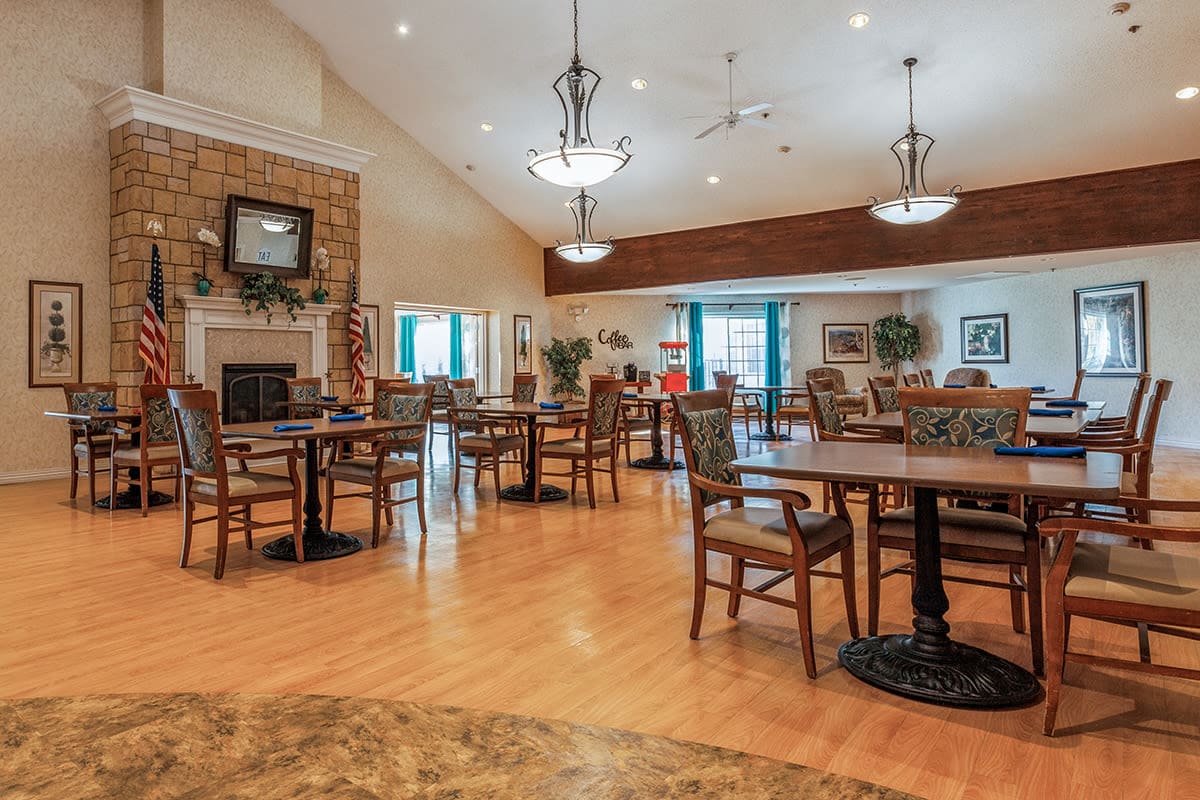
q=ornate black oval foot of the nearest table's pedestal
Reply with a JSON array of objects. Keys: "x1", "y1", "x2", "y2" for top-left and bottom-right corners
[{"x1": 838, "y1": 633, "x2": 1042, "y2": 709}]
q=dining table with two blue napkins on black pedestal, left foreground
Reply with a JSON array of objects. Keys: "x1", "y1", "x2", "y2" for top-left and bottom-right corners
[{"x1": 221, "y1": 416, "x2": 425, "y2": 561}]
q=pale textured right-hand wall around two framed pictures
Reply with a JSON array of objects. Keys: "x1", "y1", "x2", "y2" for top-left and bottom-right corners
[{"x1": 905, "y1": 248, "x2": 1200, "y2": 445}]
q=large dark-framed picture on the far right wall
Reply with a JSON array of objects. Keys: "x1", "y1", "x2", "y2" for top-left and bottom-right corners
[{"x1": 1075, "y1": 281, "x2": 1146, "y2": 378}]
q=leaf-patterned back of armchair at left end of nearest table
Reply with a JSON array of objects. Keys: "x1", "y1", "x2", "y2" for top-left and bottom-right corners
[{"x1": 672, "y1": 389, "x2": 742, "y2": 506}]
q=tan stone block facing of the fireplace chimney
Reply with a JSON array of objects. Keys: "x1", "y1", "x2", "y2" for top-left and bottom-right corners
[{"x1": 108, "y1": 120, "x2": 360, "y2": 404}]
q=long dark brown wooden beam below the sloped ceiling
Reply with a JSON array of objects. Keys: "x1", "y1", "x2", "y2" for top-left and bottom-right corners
[{"x1": 544, "y1": 160, "x2": 1200, "y2": 296}]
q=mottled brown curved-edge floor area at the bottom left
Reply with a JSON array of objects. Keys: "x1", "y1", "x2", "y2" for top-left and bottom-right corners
[{"x1": 0, "y1": 694, "x2": 912, "y2": 800}]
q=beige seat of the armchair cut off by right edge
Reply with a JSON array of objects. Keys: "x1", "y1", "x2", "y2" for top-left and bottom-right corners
[{"x1": 1066, "y1": 541, "x2": 1200, "y2": 612}]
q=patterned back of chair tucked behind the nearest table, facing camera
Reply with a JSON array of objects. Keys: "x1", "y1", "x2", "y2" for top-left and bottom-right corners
[{"x1": 900, "y1": 381, "x2": 1030, "y2": 449}]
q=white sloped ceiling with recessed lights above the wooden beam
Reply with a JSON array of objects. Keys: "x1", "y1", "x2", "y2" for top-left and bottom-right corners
[{"x1": 274, "y1": 0, "x2": 1200, "y2": 247}]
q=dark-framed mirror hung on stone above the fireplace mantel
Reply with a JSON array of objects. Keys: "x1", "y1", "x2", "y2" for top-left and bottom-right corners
[{"x1": 226, "y1": 194, "x2": 312, "y2": 277}]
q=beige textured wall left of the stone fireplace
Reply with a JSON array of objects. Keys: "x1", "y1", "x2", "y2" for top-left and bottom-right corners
[{"x1": 0, "y1": 0, "x2": 142, "y2": 480}]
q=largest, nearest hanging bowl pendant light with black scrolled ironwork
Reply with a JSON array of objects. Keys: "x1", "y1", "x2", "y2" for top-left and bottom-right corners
[{"x1": 528, "y1": 0, "x2": 632, "y2": 188}]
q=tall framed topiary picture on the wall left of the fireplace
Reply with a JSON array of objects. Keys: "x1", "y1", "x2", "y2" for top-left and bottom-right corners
[{"x1": 29, "y1": 281, "x2": 83, "y2": 389}]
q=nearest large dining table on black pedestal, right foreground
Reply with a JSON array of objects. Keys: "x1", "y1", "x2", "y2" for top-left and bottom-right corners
[{"x1": 733, "y1": 441, "x2": 1121, "y2": 708}]
